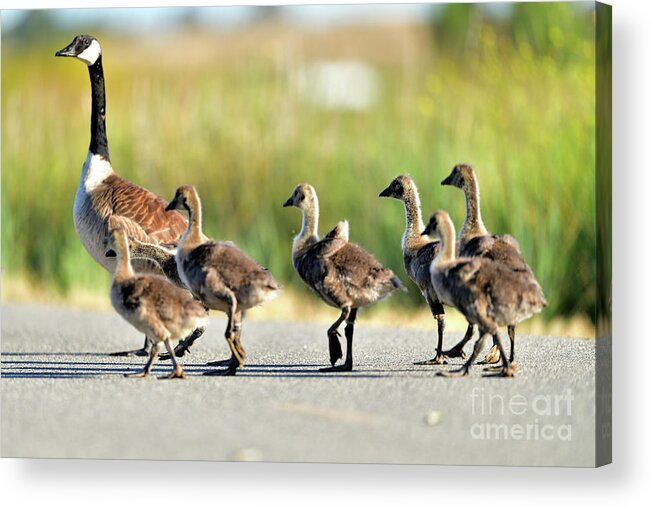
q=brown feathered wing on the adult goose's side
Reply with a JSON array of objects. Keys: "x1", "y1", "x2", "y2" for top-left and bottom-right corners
[{"x1": 104, "y1": 176, "x2": 187, "y2": 245}]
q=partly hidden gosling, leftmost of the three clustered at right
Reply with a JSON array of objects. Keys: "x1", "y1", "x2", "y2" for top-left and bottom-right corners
[{"x1": 380, "y1": 174, "x2": 473, "y2": 364}]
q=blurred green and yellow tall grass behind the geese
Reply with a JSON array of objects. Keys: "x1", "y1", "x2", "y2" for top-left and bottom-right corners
[{"x1": 2, "y1": 6, "x2": 596, "y2": 321}]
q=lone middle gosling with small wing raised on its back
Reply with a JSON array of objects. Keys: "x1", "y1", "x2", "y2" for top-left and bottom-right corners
[{"x1": 283, "y1": 183, "x2": 406, "y2": 372}]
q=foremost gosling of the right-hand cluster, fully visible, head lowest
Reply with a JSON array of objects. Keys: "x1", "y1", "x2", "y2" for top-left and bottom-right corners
[{"x1": 423, "y1": 211, "x2": 547, "y2": 377}]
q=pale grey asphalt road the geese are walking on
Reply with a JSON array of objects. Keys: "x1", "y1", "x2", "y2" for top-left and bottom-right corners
[{"x1": 0, "y1": 305, "x2": 595, "y2": 466}]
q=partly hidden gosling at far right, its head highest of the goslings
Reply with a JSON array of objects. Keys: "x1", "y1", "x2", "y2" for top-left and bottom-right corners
[{"x1": 441, "y1": 164, "x2": 533, "y2": 365}]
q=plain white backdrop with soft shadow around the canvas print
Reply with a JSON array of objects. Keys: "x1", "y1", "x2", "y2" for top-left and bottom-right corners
[{"x1": 0, "y1": 0, "x2": 651, "y2": 507}]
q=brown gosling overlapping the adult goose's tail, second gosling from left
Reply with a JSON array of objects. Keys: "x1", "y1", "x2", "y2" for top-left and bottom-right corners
[{"x1": 167, "y1": 185, "x2": 281, "y2": 375}]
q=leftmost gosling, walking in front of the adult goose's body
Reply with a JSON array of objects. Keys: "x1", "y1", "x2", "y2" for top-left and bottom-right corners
[{"x1": 108, "y1": 229, "x2": 208, "y2": 379}]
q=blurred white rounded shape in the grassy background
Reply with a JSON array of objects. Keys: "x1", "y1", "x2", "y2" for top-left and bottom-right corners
[{"x1": 296, "y1": 60, "x2": 380, "y2": 111}]
